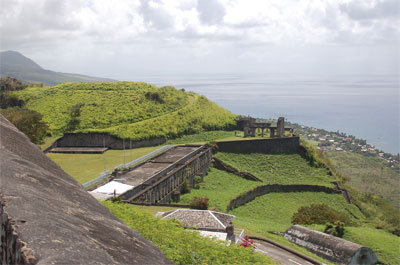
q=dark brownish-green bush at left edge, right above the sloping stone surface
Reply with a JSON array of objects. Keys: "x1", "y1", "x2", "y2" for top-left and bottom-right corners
[{"x1": 1, "y1": 107, "x2": 48, "y2": 143}]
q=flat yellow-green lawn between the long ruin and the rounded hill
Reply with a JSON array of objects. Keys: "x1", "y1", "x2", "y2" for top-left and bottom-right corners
[{"x1": 47, "y1": 143, "x2": 161, "y2": 183}]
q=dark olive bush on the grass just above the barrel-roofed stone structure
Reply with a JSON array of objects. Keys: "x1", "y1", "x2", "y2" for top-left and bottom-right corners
[{"x1": 292, "y1": 204, "x2": 349, "y2": 225}]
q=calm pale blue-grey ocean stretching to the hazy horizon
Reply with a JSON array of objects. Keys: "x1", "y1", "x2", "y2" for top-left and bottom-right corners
[{"x1": 130, "y1": 74, "x2": 400, "y2": 154}]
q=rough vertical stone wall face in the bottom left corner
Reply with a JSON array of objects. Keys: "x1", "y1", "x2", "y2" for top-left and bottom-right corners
[{"x1": 0, "y1": 198, "x2": 36, "y2": 264}]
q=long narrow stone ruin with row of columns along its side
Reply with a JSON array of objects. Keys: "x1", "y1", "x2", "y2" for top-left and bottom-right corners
[{"x1": 118, "y1": 145, "x2": 212, "y2": 204}]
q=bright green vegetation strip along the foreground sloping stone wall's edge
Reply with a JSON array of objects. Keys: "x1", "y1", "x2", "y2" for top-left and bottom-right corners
[{"x1": 103, "y1": 202, "x2": 274, "y2": 264}]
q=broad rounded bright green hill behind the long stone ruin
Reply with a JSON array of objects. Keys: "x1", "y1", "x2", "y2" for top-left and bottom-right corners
[{"x1": 15, "y1": 82, "x2": 235, "y2": 140}]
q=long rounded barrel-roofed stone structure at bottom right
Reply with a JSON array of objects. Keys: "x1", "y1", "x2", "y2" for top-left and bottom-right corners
[{"x1": 284, "y1": 225, "x2": 378, "y2": 265}]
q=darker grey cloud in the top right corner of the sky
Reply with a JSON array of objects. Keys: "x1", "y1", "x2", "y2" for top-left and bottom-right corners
[{"x1": 340, "y1": 0, "x2": 400, "y2": 20}]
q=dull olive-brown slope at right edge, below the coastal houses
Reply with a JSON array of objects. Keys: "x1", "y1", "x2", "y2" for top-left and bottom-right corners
[{"x1": 326, "y1": 152, "x2": 400, "y2": 208}]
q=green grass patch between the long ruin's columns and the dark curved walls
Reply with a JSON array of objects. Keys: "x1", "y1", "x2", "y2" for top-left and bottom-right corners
[{"x1": 180, "y1": 167, "x2": 261, "y2": 212}]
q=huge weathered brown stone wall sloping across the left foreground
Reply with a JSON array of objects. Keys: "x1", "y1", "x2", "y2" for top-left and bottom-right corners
[{"x1": 0, "y1": 115, "x2": 172, "y2": 264}]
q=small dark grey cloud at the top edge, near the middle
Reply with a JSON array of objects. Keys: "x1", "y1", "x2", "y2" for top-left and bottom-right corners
[{"x1": 197, "y1": 0, "x2": 226, "y2": 25}]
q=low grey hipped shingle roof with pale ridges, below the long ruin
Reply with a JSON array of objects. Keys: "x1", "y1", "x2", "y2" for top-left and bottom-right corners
[{"x1": 156, "y1": 209, "x2": 235, "y2": 230}]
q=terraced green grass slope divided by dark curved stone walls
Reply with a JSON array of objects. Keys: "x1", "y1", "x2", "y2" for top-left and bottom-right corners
[{"x1": 182, "y1": 152, "x2": 400, "y2": 264}]
